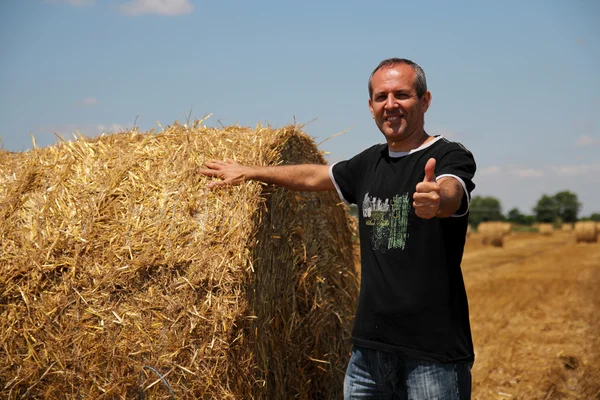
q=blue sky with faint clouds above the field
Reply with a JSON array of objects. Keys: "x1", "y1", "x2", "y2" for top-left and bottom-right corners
[{"x1": 0, "y1": 0, "x2": 600, "y2": 215}]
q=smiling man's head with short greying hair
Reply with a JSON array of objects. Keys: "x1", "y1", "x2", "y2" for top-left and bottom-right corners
[{"x1": 369, "y1": 58, "x2": 431, "y2": 151}]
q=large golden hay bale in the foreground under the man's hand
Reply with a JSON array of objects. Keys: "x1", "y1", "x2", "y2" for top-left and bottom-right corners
[{"x1": 0, "y1": 122, "x2": 358, "y2": 399}]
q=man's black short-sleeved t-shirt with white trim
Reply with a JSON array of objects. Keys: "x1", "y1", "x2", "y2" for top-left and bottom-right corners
[{"x1": 330, "y1": 136, "x2": 475, "y2": 362}]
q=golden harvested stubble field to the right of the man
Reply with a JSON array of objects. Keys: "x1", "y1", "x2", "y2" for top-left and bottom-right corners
[{"x1": 463, "y1": 231, "x2": 600, "y2": 400}]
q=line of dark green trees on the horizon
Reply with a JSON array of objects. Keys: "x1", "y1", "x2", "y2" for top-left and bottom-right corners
[{"x1": 469, "y1": 190, "x2": 600, "y2": 226}]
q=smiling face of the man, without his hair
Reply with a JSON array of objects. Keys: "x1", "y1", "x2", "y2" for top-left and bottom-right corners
[{"x1": 369, "y1": 64, "x2": 431, "y2": 150}]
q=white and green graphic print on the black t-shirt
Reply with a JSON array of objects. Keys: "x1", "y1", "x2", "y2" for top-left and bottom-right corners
[{"x1": 362, "y1": 192, "x2": 410, "y2": 252}]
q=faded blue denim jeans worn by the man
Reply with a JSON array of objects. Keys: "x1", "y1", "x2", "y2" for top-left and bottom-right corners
[{"x1": 344, "y1": 346, "x2": 473, "y2": 400}]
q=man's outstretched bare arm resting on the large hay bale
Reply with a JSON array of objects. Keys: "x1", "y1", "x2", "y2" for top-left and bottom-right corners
[{"x1": 200, "y1": 159, "x2": 335, "y2": 191}]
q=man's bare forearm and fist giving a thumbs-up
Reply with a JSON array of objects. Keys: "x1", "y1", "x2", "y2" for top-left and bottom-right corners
[{"x1": 413, "y1": 158, "x2": 464, "y2": 219}]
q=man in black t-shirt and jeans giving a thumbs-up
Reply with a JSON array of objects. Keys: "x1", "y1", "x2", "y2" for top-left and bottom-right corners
[{"x1": 202, "y1": 58, "x2": 475, "y2": 399}]
